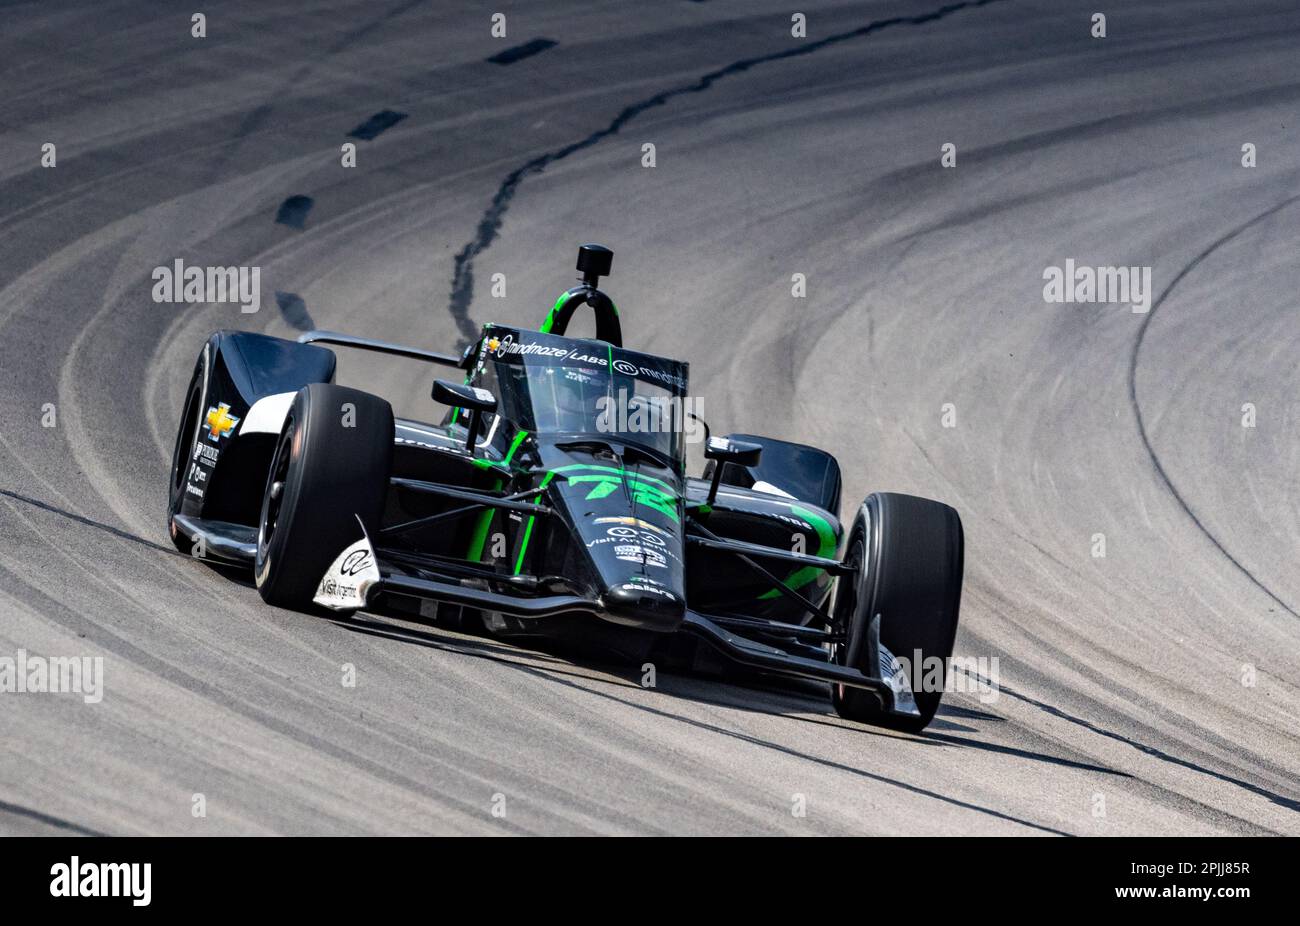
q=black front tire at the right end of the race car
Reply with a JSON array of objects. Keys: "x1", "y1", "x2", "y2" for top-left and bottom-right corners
[{"x1": 831, "y1": 492, "x2": 965, "y2": 732}]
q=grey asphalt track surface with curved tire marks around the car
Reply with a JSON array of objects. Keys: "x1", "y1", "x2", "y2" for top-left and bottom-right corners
[{"x1": 0, "y1": 0, "x2": 1300, "y2": 835}]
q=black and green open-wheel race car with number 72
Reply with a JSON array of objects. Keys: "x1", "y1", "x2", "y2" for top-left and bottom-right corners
[{"x1": 168, "y1": 245, "x2": 965, "y2": 731}]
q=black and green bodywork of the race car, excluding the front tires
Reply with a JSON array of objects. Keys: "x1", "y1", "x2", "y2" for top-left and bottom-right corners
[{"x1": 170, "y1": 248, "x2": 925, "y2": 711}]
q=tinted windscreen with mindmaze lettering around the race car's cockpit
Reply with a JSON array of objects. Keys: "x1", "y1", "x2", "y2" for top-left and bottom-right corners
[{"x1": 470, "y1": 328, "x2": 688, "y2": 463}]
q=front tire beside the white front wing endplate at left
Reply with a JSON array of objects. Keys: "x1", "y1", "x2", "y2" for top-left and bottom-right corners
[{"x1": 254, "y1": 382, "x2": 393, "y2": 611}]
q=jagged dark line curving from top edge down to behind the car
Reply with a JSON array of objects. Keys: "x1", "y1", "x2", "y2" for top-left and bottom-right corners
[{"x1": 447, "y1": 0, "x2": 1002, "y2": 346}]
